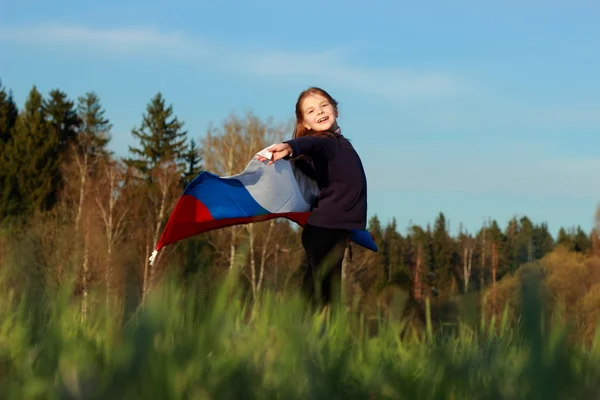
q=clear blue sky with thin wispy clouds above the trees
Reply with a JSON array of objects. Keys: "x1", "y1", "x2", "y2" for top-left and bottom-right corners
[{"x1": 0, "y1": 0, "x2": 600, "y2": 233}]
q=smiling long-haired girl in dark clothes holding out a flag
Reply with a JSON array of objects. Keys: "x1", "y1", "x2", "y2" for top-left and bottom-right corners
[{"x1": 256, "y1": 87, "x2": 367, "y2": 305}]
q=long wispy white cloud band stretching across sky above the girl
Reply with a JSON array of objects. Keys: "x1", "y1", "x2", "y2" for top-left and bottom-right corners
[{"x1": 0, "y1": 24, "x2": 600, "y2": 135}]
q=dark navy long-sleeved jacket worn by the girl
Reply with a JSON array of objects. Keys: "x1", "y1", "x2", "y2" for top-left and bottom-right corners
[{"x1": 285, "y1": 133, "x2": 367, "y2": 229}]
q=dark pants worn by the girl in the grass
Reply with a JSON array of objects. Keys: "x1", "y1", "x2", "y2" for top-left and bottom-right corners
[{"x1": 302, "y1": 224, "x2": 350, "y2": 306}]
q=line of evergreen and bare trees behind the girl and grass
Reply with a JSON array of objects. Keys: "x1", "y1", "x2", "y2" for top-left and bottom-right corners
[{"x1": 0, "y1": 79, "x2": 598, "y2": 315}]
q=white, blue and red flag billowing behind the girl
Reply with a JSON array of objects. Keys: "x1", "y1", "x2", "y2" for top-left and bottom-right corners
[{"x1": 150, "y1": 150, "x2": 378, "y2": 262}]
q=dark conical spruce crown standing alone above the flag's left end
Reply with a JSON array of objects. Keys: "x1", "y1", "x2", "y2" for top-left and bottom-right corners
[{"x1": 125, "y1": 92, "x2": 188, "y2": 177}]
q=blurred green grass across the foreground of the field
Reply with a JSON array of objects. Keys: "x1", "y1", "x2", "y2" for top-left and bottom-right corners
[{"x1": 0, "y1": 268, "x2": 600, "y2": 400}]
